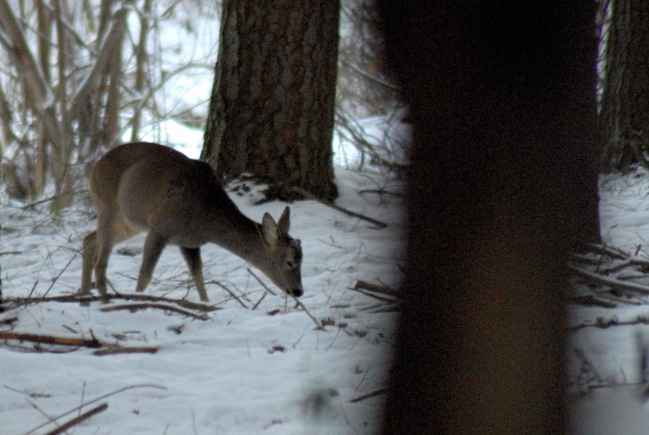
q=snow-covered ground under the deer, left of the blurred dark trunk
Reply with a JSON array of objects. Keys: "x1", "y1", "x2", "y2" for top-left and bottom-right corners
[{"x1": 0, "y1": 161, "x2": 405, "y2": 435}]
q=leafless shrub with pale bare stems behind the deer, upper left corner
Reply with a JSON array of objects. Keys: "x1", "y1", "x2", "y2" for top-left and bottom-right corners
[{"x1": 0, "y1": 0, "x2": 218, "y2": 207}]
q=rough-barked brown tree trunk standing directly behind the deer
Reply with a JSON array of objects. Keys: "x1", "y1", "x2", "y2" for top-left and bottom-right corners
[{"x1": 201, "y1": 0, "x2": 340, "y2": 200}]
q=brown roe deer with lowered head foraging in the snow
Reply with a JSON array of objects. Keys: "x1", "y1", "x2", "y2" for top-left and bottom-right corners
[{"x1": 81, "y1": 142, "x2": 302, "y2": 302}]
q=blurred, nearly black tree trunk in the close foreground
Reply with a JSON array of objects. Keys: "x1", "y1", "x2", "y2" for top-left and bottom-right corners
[{"x1": 379, "y1": 0, "x2": 598, "y2": 435}]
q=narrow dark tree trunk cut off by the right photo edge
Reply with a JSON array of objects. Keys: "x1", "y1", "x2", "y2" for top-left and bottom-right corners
[{"x1": 600, "y1": 0, "x2": 649, "y2": 171}]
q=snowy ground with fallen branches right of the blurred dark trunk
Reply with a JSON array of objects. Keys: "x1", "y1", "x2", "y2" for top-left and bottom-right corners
[{"x1": 567, "y1": 169, "x2": 649, "y2": 435}]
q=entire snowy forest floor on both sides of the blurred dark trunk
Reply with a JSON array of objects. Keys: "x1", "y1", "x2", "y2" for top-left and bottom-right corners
[{"x1": 8, "y1": 154, "x2": 649, "y2": 435}]
